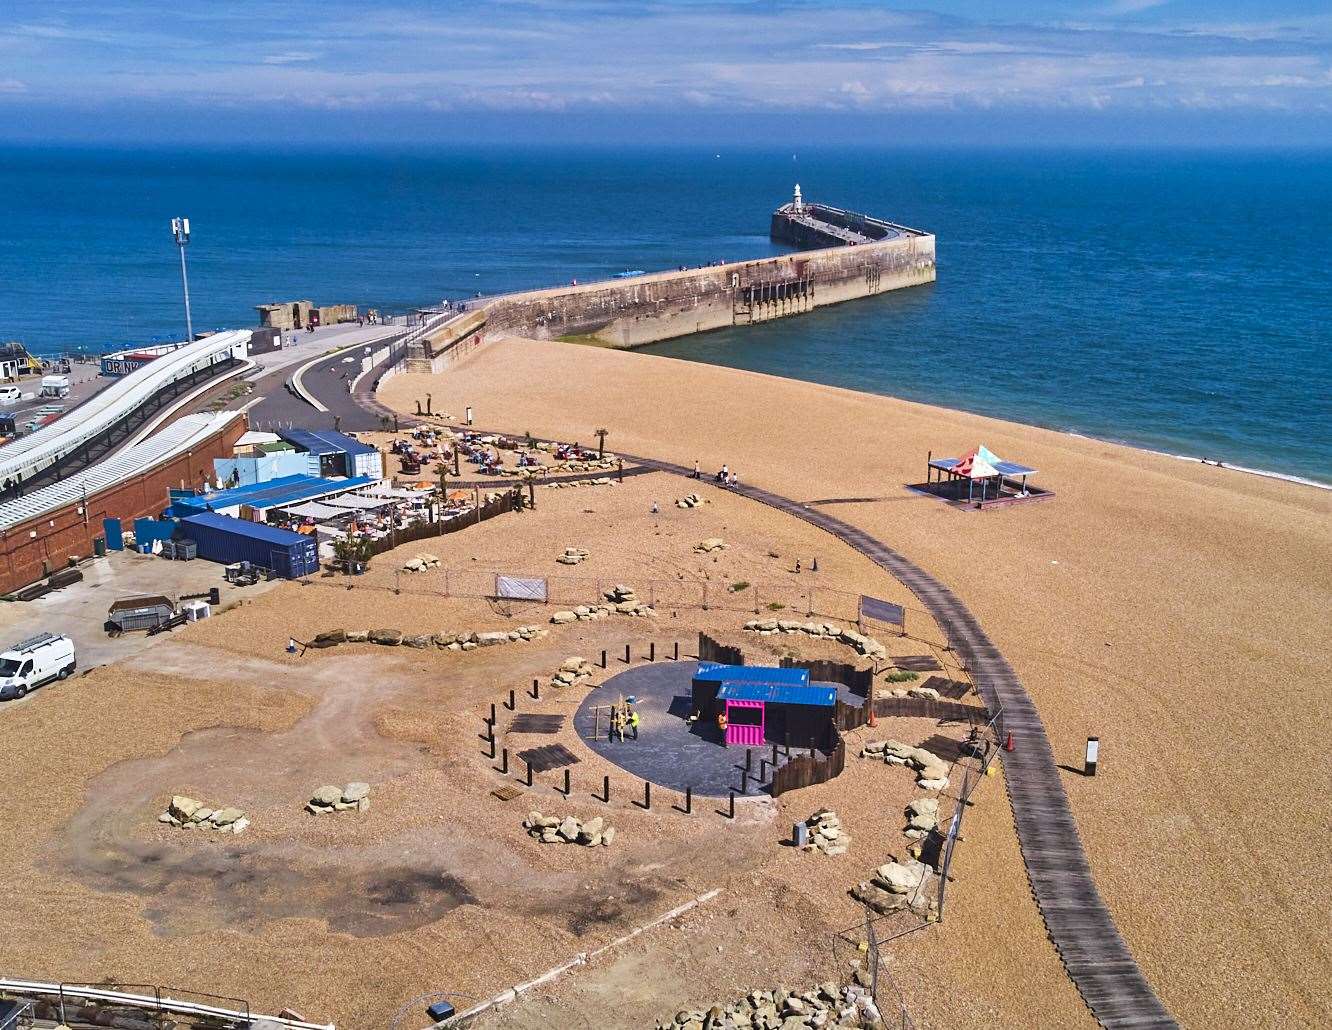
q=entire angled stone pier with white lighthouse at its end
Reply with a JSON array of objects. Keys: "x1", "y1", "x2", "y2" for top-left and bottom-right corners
[{"x1": 406, "y1": 187, "x2": 935, "y2": 372}]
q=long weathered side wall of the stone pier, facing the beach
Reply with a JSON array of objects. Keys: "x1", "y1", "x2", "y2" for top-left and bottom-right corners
[{"x1": 429, "y1": 232, "x2": 935, "y2": 353}]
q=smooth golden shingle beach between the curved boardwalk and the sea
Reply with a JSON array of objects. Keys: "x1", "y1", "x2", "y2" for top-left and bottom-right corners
[{"x1": 384, "y1": 340, "x2": 1332, "y2": 1026}]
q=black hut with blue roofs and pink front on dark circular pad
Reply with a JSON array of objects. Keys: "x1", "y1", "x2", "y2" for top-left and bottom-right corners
[{"x1": 693, "y1": 662, "x2": 836, "y2": 748}]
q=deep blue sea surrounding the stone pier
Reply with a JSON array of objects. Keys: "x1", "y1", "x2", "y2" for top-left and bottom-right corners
[{"x1": 0, "y1": 144, "x2": 1332, "y2": 482}]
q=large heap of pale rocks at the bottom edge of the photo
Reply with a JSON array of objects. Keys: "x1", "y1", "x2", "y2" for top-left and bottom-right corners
[{"x1": 657, "y1": 975, "x2": 883, "y2": 1030}]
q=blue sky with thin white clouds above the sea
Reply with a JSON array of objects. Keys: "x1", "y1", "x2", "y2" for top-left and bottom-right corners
[{"x1": 0, "y1": 0, "x2": 1332, "y2": 145}]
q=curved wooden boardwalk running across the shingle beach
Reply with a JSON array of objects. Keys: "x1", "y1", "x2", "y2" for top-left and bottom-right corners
[{"x1": 343, "y1": 392, "x2": 1177, "y2": 1030}]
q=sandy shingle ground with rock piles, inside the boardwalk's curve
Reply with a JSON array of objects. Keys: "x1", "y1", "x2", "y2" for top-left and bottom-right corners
[{"x1": 0, "y1": 455, "x2": 1001, "y2": 1030}]
